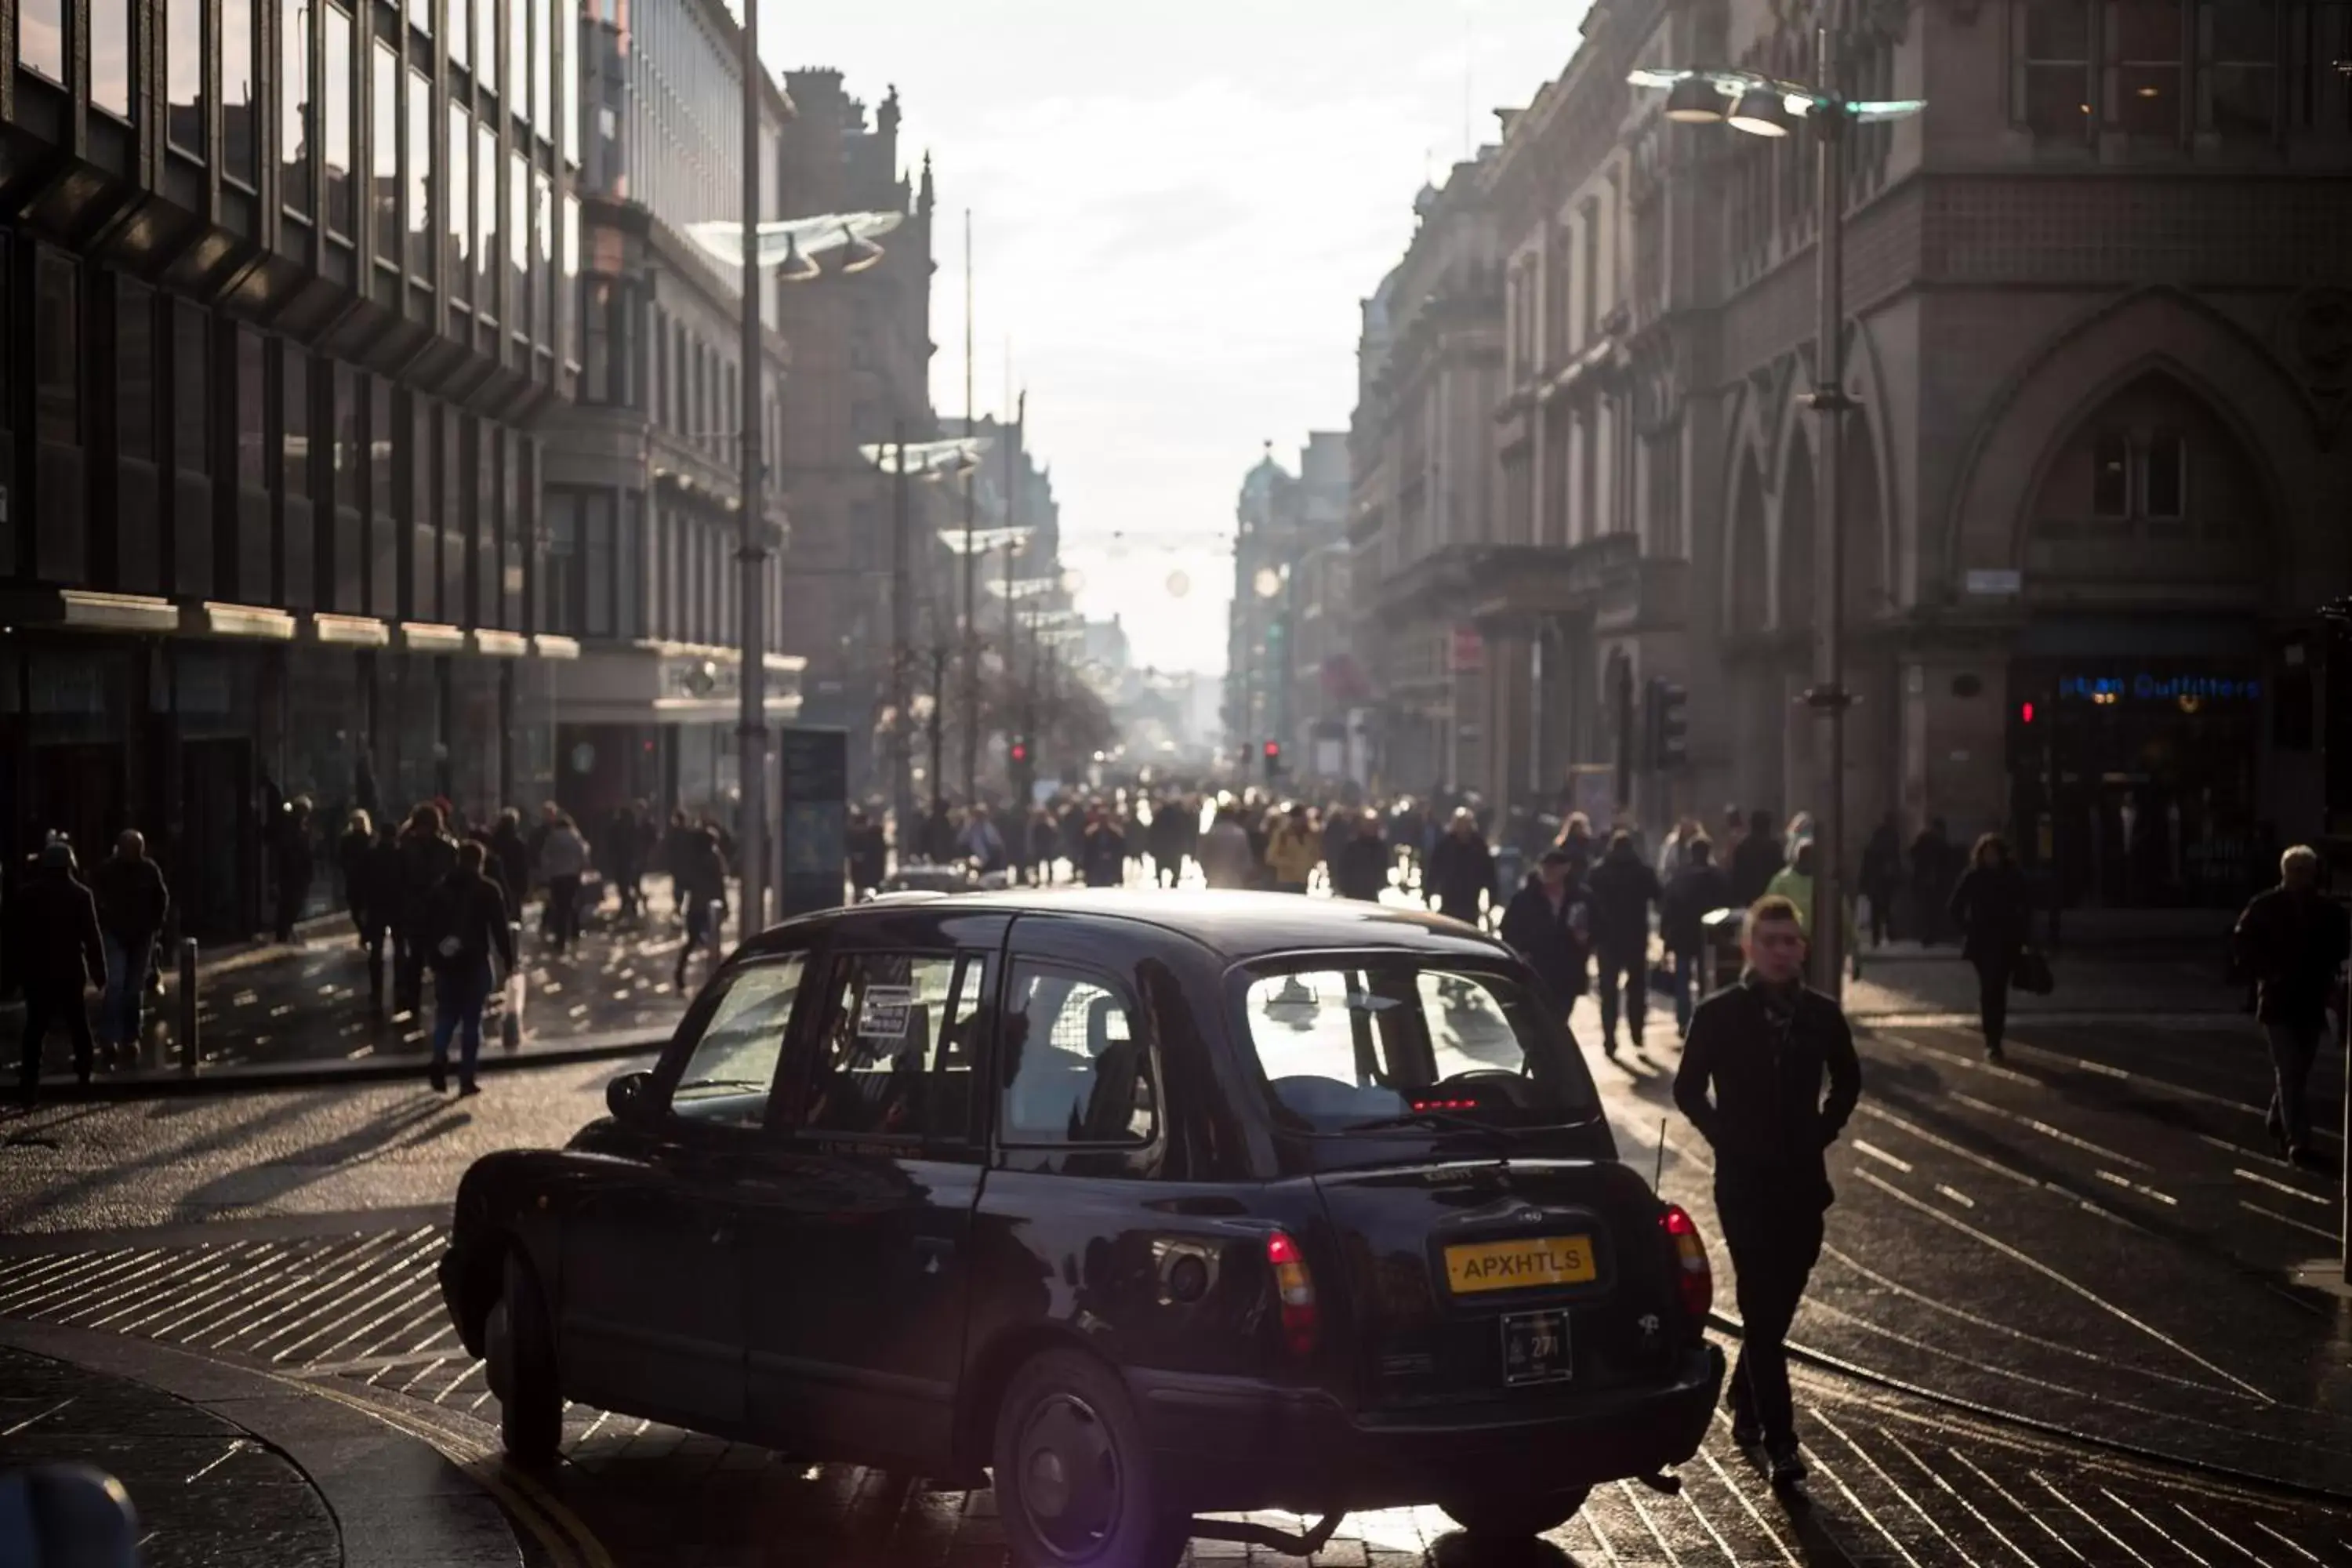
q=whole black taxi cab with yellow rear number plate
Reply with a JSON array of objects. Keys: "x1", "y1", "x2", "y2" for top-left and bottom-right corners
[{"x1": 440, "y1": 891, "x2": 1722, "y2": 1568}]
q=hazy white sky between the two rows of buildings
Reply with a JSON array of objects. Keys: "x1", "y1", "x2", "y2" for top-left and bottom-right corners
[{"x1": 760, "y1": 0, "x2": 1585, "y2": 670}]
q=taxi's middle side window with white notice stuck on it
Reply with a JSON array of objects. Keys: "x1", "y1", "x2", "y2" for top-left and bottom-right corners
[{"x1": 802, "y1": 952, "x2": 988, "y2": 1140}]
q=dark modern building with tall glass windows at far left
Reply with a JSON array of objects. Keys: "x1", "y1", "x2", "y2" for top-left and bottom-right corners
[{"x1": 0, "y1": 0, "x2": 581, "y2": 938}]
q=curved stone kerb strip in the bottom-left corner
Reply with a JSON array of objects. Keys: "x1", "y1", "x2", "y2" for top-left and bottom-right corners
[{"x1": 0, "y1": 1319, "x2": 522, "y2": 1568}]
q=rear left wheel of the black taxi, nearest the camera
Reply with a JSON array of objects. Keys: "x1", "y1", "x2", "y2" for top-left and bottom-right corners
[{"x1": 990, "y1": 1349, "x2": 1192, "y2": 1568}]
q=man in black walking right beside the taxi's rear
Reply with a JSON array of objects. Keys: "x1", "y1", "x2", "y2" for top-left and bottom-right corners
[{"x1": 1675, "y1": 895, "x2": 1863, "y2": 1488}]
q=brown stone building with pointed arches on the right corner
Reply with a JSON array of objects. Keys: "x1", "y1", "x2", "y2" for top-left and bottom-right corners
[{"x1": 1355, "y1": 0, "x2": 2352, "y2": 905}]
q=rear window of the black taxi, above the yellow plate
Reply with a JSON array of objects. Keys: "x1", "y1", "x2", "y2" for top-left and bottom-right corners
[{"x1": 1242, "y1": 959, "x2": 1599, "y2": 1135}]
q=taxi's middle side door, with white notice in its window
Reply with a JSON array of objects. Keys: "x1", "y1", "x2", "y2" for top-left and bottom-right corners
[{"x1": 739, "y1": 914, "x2": 1007, "y2": 1467}]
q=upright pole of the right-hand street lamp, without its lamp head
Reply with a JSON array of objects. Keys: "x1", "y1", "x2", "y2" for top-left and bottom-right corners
[{"x1": 1806, "y1": 26, "x2": 1853, "y2": 996}]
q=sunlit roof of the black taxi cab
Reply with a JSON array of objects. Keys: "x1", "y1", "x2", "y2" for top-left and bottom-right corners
[{"x1": 750, "y1": 886, "x2": 1503, "y2": 959}]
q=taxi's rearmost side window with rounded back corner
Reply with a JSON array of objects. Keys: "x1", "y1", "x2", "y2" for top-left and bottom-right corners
[{"x1": 997, "y1": 964, "x2": 1160, "y2": 1147}]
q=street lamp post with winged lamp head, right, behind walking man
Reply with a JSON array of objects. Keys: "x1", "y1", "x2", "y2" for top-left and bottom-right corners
[{"x1": 1625, "y1": 27, "x2": 1926, "y2": 996}]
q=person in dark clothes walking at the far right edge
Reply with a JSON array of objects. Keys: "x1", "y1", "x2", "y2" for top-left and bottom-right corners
[{"x1": 2230, "y1": 844, "x2": 2352, "y2": 1163}]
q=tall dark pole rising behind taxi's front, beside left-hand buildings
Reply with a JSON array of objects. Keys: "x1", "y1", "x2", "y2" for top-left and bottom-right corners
[{"x1": 736, "y1": 0, "x2": 783, "y2": 935}]
